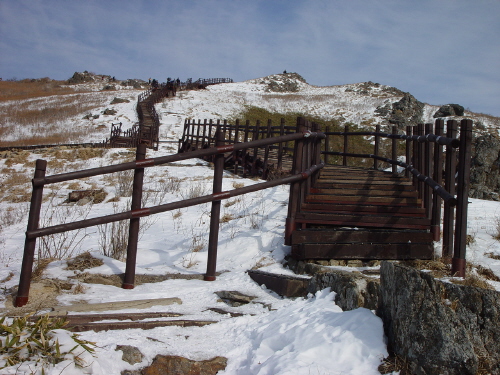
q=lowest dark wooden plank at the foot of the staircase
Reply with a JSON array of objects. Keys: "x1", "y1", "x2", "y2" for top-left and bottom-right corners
[{"x1": 292, "y1": 244, "x2": 434, "y2": 259}]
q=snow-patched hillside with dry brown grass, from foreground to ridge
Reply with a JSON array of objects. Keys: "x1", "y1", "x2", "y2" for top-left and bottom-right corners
[{"x1": 0, "y1": 73, "x2": 500, "y2": 375}]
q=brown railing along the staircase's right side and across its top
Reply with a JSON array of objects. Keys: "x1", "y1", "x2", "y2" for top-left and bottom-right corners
[{"x1": 322, "y1": 119, "x2": 472, "y2": 277}]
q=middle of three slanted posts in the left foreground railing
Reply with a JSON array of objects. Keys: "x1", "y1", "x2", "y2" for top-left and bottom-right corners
[{"x1": 122, "y1": 143, "x2": 146, "y2": 289}]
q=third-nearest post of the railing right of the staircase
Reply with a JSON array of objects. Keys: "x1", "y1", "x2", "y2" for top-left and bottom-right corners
[{"x1": 431, "y1": 119, "x2": 444, "y2": 242}]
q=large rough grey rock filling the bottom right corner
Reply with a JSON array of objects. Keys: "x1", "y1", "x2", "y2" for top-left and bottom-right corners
[{"x1": 378, "y1": 262, "x2": 500, "y2": 375}]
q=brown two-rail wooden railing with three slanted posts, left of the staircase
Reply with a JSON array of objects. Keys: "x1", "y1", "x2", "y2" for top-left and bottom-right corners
[{"x1": 15, "y1": 131, "x2": 325, "y2": 307}]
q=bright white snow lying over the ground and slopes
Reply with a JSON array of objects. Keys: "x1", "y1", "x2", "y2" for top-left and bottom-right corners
[{"x1": 0, "y1": 75, "x2": 500, "y2": 375}]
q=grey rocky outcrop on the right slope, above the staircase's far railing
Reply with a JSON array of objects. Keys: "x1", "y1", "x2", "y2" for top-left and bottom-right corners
[{"x1": 375, "y1": 92, "x2": 424, "y2": 129}]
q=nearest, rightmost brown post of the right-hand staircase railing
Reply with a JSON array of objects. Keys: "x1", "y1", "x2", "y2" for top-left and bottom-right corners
[{"x1": 451, "y1": 120, "x2": 472, "y2": 277}]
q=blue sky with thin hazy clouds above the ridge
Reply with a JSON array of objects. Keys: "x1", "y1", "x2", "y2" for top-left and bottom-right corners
[{"x1": 0, "y1": 0, "x2": 500, "y2": 116}]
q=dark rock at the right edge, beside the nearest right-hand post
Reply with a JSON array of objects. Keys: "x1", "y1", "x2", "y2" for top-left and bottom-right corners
[{"x1": 469, "y1": 134, "x2": 500, "y2": 201}]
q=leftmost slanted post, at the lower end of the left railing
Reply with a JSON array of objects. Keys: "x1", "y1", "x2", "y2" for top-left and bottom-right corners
[{"x1": 14, "y1": 159, "x2": 47, "y2": 307}]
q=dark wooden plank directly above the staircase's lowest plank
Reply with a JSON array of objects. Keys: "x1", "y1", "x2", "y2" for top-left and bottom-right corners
[{"x1": 292, "y1": 229, "x2": 432, "y2": 245}]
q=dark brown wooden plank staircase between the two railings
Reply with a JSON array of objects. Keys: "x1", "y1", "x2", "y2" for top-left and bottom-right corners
[{"x1": 291, "y1": 165, "x2": 434, "y2": 260}]
